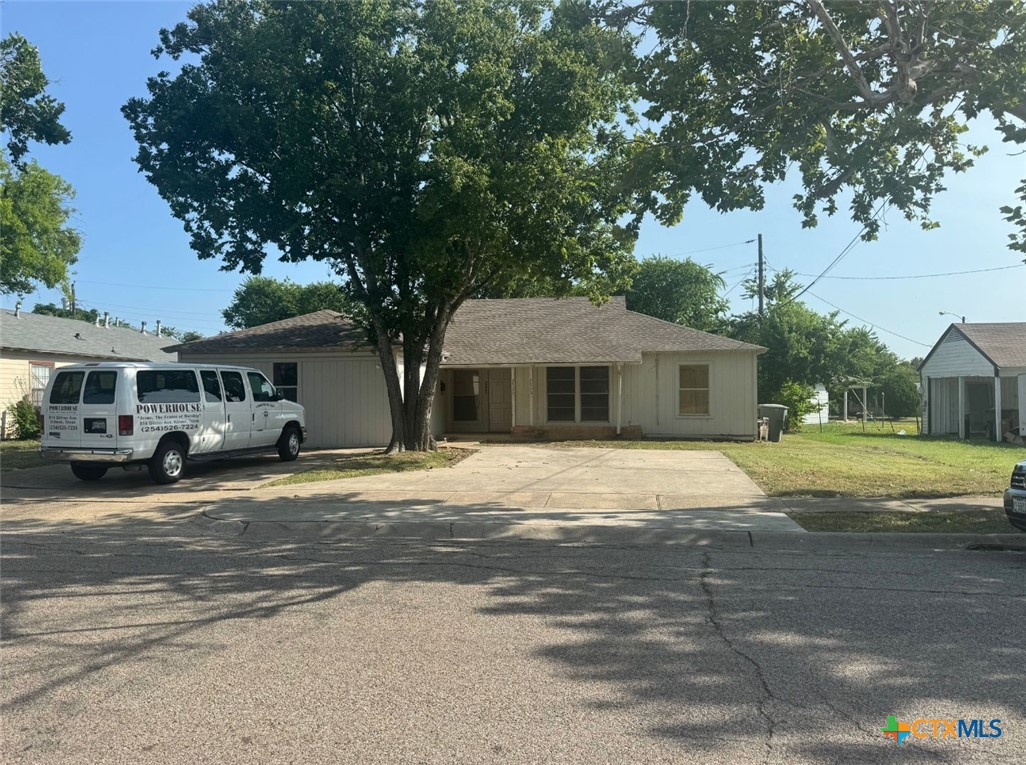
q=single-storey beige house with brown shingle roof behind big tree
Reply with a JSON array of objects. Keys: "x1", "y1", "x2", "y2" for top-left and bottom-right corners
[{"x1": 177, "y1": 297, "x2": 765, "y2": 447}]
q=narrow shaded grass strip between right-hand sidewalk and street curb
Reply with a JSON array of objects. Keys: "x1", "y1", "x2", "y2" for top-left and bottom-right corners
[{"x1": 788, "y1": 510, "x2": 1016, "y2": 534}]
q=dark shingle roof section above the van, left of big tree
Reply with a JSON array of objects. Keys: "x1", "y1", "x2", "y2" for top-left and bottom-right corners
[{"x1": 175, "y1": 310, "x2": 371, "y2": 354}]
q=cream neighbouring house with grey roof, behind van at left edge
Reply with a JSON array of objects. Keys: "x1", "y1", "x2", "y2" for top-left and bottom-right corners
[{"x1": 0, "y1": 311, "x2": 177, "y2": 436}]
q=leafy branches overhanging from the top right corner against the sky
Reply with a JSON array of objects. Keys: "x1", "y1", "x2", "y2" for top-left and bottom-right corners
[{"x1": 606, "y1": 0, "x2": 1026, "y2": 250}]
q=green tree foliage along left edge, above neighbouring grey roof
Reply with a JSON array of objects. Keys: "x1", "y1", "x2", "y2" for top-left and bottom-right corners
[{"x1": 0, "y1": 34, "x2": 81, "y2": 294}]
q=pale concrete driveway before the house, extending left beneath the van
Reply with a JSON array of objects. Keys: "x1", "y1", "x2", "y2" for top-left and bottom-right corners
[{"x1": 2, "y1": 446, "x2": 801, "y2": 531}]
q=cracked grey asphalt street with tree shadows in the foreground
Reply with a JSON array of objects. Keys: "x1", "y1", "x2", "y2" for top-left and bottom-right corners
[{"x1": 2, "y1": 507, "x2": 1026, "y2": 764}]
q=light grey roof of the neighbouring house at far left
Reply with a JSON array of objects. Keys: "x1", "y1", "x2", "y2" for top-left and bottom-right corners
[{"x1": 0, "y1": 311, "x2": 177, "y2": 361}]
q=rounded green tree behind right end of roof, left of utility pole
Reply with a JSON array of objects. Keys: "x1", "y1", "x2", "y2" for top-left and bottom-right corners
[{"x1": 626, "y1": 255, "x2": 728, "y2": 331}]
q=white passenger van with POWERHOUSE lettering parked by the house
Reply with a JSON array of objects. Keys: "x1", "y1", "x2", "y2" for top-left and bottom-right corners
[{"x1": 40, "y1": 362, "x2": 307, "y2": 483}]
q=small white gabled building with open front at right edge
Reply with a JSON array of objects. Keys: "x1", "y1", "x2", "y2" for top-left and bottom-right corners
[{"x1": 919, "y1": 322, "x2": 1026, "y2": 441}]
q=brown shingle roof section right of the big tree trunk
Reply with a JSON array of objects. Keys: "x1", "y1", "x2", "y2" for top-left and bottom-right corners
[{"x1": 442, "y1": 297, "x2": 765, "y2": 366}]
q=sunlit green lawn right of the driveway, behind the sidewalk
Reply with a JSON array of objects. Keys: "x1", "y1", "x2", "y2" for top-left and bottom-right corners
[{"x1": 558, "y1": 421, "x2": 1026, "y2": 498}]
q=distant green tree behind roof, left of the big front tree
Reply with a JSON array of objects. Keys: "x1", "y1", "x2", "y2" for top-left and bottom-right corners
[{"x1": 221, "y1": 276, "x2": 362, "y2": 329}]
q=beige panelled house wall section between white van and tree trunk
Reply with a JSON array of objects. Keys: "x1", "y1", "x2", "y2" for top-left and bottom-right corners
[{"x1": 300, "y1": 359, "x2": 392, "y2": 448}]
